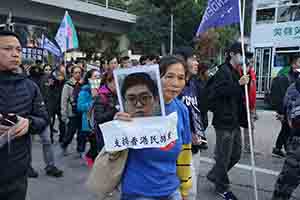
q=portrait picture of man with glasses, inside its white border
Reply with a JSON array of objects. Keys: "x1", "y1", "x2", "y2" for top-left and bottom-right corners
[{"x1": 117, "y1": 65, "x2": 166, "y2": 117}]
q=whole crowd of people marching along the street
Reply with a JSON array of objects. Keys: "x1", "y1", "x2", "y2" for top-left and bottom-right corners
[{"x1": 0, "y1": 31, "x2": 300, "y2": 200}]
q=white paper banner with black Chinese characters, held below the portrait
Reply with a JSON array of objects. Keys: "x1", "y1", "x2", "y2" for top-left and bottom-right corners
[{"x1": 99, "y1": 113, "x2": 178, "y2": 152}]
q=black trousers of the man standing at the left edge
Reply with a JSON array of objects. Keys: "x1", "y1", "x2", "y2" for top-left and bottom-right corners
[{"x1": 0, "y1": 176, "x2": 27, "y2": 200}]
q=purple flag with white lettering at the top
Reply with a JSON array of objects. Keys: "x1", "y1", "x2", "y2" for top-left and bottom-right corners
[{"x1": 197, "y1": 0, "x2": 240, "y2": 37}]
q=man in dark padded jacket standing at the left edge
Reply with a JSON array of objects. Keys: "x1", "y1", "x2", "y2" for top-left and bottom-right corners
[{"x1": 0, "y1": 31, "x2": 49, "y2": 200}]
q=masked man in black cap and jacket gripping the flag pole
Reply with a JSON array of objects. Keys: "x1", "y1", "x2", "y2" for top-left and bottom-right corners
[{"x1": 207, "y1": 43, "x2": 249, "y2": 200}]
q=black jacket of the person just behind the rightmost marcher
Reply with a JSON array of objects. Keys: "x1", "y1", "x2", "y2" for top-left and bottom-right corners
[{"x1": 271, "y1": 70, "x2": 298, "y2": 115}]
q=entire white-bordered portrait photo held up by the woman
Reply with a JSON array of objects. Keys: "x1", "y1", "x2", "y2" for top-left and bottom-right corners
[{"x1": 114, "y1": 65, "x2": 165, "y2": 117}]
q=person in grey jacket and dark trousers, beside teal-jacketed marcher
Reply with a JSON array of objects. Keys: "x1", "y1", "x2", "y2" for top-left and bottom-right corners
[{"x1": 61, "y1": 66, "x2": 83, "y2": 156}]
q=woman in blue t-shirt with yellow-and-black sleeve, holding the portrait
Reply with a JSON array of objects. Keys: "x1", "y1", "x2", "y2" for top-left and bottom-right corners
[{"x1": 115, "y1": 56, "x2": 192, "y2": 200}]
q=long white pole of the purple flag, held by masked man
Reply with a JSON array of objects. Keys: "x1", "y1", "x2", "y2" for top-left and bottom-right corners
[{"x1": 238, "y1": 0, "x2": 258, "y2": 200}]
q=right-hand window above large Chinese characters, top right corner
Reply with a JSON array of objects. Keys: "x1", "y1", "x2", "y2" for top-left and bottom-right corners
[{"x1": 277, "y1": 5, "x2": 300, "y2": 22}]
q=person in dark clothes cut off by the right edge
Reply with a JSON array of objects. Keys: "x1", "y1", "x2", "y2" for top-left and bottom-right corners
[{"x1": 272, "y1": 74, "x2": 300, "y2": 200}]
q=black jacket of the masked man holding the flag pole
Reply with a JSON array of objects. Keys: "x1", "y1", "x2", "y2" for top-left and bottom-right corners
[{"x1": 212, "y1": 63, "x2": 247, "y2": 130}]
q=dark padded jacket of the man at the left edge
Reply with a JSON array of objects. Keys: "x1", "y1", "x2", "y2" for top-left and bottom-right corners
[{"x1": 0, "y1": 72, "x2": 49, "y2": 184}]
